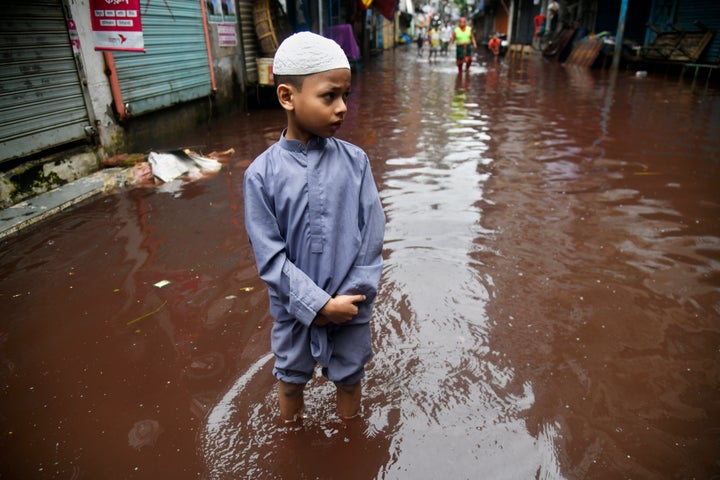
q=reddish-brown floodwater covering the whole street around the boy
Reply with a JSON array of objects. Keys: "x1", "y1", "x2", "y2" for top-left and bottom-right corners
[{"x1": 0, "y1": 50, "x2": 720, "y2": 480}]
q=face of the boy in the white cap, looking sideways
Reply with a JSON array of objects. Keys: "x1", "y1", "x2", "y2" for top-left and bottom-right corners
[{"x1": 278, "y1": 68, "x2": 350, "y2": 145}]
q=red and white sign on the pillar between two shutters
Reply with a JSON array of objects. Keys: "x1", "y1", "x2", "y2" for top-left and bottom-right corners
[{"x1": 90, "y1": 0, "x2": 145, "y2": 52}]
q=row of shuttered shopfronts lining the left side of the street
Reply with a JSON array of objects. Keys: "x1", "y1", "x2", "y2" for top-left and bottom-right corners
[{"x1": 0, "y1": 0, "x2": 395, "y2": 208}]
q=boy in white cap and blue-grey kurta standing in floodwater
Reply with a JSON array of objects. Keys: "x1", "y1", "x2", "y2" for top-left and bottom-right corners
[{"x1": 243, "y1": 32, "x2": 385, "y2": 423}]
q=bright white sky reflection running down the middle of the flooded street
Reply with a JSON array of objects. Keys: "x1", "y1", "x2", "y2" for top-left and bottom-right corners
[{"x1": 371, "y1": 60, "x2": 559, "y2": 478}]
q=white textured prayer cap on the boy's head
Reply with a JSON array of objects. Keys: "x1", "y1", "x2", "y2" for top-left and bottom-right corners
[{"x1": 273, "y1": 32, "x2": 350, "y2": 75}]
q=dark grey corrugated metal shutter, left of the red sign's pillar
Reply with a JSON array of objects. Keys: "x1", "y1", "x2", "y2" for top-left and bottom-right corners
[{"x1": 0, "y1": 0, "x2": 90, "y2": 162}]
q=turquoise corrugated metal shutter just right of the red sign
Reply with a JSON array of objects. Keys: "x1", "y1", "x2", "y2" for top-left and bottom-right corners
[{"x1": 113, "y1": 0, "x2": 212, "y2": 116}]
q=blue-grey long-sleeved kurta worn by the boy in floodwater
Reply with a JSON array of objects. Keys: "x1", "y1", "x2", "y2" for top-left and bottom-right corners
[{"x1": 243, "y1": 134, "x2": 385, "y2": 382}]
